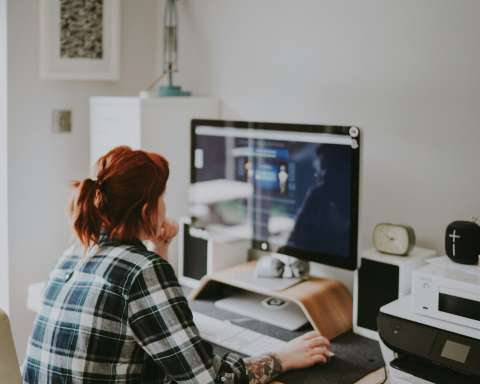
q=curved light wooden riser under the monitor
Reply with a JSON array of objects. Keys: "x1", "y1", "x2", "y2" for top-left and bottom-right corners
[{"x1": 190, "y1": 261, "x2": 353, "y2": 339}]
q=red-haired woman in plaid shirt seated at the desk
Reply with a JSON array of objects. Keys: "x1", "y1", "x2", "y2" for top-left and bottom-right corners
[{"x1": 23, "y1": 147, "x2": 329, "y2": 384}]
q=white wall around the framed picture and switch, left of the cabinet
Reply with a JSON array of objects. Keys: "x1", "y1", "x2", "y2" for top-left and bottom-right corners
[{"x1": 8, "y1": 0, "x2": 157, "y2": 359}]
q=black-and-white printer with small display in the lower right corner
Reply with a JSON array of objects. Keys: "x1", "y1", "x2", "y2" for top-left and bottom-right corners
[{"x1": 378, "y1": 258, "x2": 480, "y2": 384}]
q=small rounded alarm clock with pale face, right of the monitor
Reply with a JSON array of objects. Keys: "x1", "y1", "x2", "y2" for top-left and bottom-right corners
[{"x1": 373, "y1": 223, "x2": 415, "y2": 256}]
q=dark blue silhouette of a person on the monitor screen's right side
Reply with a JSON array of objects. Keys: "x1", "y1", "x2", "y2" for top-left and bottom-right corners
[{"x1": 288, "y1": 144, "x2": 351, "y2": 257}]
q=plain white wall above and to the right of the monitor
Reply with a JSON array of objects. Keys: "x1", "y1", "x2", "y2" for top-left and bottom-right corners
[{"x1": 174, "y1": 0, "x2": 480, "y2": 270}]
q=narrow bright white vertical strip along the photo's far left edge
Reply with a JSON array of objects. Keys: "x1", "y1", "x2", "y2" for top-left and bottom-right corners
[{"x1": 0, "y1": 0, "x2": 9, "y2": 312}]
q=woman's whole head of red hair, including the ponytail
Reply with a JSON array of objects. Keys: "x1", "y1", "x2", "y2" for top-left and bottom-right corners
[{"x1": 70, "y1": 146, "x2": 169, "y2": 247}]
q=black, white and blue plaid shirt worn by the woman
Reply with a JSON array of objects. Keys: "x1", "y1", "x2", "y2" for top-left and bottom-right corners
[{"x1": 22, "y1": 239, "x2": 247, "y2": 384}]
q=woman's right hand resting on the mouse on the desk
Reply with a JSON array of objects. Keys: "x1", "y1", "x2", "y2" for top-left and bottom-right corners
[{"x1": 275, "y1": 331, "x2": 332, "y2": 372}]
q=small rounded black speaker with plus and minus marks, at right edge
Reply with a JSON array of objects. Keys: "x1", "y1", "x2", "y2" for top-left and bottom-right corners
[{"x1": 445, "y1": 221, "x2": 480, "y2": 264}]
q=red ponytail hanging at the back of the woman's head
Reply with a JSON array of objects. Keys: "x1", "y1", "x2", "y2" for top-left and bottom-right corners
[{"x1": 71, "y1": 179, "x2": 103, "y2": 247}]
